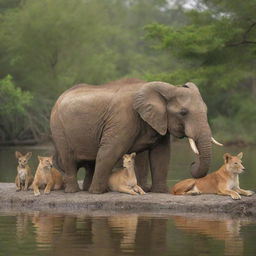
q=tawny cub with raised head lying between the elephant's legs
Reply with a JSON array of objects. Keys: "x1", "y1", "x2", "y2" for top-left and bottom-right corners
[{"x1": 108, "y1": 153, "x2": 146, "y2": 195}]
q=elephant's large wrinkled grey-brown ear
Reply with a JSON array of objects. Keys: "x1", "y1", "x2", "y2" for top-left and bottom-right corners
[{"x1": 133, "y1": 82, "x2": 171, "y2": 135}]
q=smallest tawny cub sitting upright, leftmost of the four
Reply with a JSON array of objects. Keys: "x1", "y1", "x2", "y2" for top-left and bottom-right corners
[{"x1": 15, "y1": 151, "x2": 33, "y2": 191}]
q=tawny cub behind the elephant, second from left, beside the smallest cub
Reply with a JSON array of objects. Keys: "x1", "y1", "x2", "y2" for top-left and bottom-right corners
[{"x1": 32, "y1": 156, "x2": 63, "y2": 196}]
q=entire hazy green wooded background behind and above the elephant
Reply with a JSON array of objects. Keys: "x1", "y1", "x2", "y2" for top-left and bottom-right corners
[{"x1": 0, "y1": 0, "x2": 256, "y2": 145}]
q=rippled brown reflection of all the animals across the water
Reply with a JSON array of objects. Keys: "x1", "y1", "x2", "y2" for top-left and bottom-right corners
[{"x1": 8, "y1": 212, "x2": 256, "y2": 256}]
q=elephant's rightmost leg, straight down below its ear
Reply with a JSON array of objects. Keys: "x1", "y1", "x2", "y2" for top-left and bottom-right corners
[{"x1": 149, "y1": 135, "x2": 170, "y2": 193}]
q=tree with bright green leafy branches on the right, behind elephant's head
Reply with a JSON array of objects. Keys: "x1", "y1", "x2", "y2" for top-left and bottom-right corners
[{"x1": 146, "y1": 0, "x2": 256, "y2": 143}]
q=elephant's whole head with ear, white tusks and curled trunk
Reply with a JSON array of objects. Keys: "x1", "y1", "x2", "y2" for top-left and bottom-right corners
[{"x1": 133, "y1": 82, "x2": 222, "y2": 178}]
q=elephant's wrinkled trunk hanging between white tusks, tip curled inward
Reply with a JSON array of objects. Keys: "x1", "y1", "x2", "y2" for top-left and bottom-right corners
[{"x1": 190, "y1": 128, "x2": 212, "y2": 178}]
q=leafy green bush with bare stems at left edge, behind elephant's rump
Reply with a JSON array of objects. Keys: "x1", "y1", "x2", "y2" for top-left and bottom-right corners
[{"x1": 0, "y1": 75, "x2": 51, "y2": 145}]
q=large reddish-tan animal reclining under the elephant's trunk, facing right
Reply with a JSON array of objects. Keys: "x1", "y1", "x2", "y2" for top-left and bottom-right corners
[{"x1": 171, "y1": 152, "x2": 254, "y2": 199}]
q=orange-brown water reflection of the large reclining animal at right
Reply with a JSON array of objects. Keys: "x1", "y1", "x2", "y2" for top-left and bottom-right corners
[{"x1": 173, "y1": 216, "x2": 245, "y2": 256}]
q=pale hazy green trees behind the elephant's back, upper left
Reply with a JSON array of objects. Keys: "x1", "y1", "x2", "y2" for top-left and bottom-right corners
[{"x1": 0, "y1": 0, "x2": 182, "y2": 144}]
